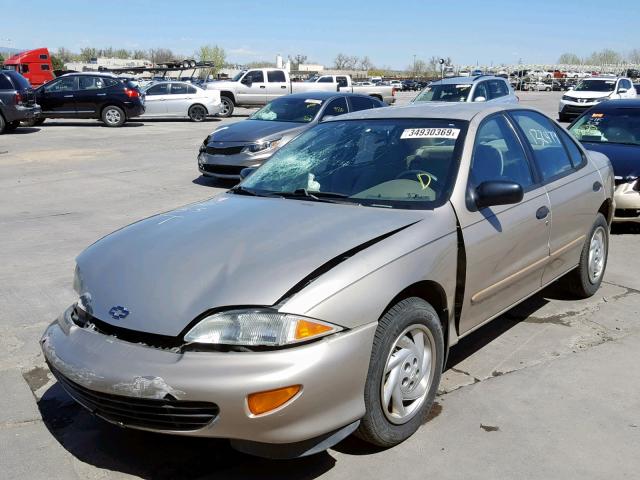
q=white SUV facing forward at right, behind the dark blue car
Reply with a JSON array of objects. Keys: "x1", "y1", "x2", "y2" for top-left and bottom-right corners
[{"x1": 558, "y1": 76, "x2": 637, "y2": 122}]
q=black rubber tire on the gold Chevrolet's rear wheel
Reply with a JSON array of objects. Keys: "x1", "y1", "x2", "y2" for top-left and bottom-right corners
[{"x1": 562, "y1": 213, "x2": 609, "y2": 298}]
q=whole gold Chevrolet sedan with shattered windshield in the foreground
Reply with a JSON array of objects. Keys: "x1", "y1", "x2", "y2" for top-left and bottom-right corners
[{"x1": 41, "y1": 104, "x2": 614, "y2": 457}]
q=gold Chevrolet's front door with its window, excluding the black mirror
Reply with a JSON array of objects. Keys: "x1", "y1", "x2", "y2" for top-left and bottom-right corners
[{"x1": 458, "y1": 115, "x2": 551, "y2": 334}]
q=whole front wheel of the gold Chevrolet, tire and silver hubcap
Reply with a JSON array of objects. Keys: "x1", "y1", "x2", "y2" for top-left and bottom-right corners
[{"x1": 356, "y1": 297, "x2": 444, "y2": 447}]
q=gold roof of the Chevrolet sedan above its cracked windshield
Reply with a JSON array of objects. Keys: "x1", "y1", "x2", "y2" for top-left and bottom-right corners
[{"x1": 326, "y1": 102, "x2": 544, "y2": 122}]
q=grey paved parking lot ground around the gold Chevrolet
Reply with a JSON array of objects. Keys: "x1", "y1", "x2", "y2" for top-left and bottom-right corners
[{"x1": 0, "y1": 92, "x2": 640, "y2": 479}]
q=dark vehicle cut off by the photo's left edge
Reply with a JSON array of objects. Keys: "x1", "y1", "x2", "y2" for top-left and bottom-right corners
[{"x1": 0, "y1": 70, "x2": 40, "y2": 134}]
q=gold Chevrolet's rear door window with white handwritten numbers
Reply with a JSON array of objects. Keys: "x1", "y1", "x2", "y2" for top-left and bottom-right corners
[{"x1": 511, "y1": 111, "x2": 573, "y2": 181}]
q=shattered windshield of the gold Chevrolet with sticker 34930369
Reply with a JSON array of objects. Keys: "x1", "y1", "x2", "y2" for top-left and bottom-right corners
[{"x1": 241, "y1": 119, "x2": 466, "y2": 208}]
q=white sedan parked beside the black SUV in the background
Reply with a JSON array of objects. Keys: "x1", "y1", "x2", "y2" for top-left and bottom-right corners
[{"x1": 142, "y1": 81, "x2": 222, "y2": 122}]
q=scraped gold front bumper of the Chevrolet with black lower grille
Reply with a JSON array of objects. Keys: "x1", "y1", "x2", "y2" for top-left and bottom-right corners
[{"x1": 41, "y1": 311, "x2": 377, "y2": 456}]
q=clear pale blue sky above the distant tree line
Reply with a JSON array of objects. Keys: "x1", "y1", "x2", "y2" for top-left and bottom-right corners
[{"x1": 0, "y1": 0, "x2": 640, "y2": 68}]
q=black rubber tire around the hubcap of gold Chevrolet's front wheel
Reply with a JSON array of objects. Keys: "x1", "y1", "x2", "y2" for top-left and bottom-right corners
[{"x1": 356, "y1": 297, "x2": 444, "y2": 447}]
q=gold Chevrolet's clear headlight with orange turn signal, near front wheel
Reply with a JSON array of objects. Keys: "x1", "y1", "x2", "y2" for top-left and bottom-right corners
[{"x1": 184, "y1": 309, "x2": 342, "y2": 347}]
